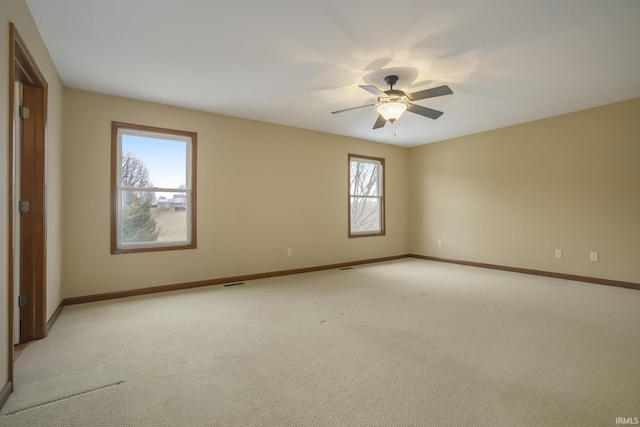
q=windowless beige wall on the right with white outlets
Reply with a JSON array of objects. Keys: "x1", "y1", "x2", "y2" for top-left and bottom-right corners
[{"x1": 410, "y1": 99, "x2": 640, "y2": 283}]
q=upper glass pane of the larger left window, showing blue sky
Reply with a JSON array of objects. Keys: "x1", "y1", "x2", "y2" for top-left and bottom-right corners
[{"x1": 122, "y1": 133, "x2": 187, "y2": 188}]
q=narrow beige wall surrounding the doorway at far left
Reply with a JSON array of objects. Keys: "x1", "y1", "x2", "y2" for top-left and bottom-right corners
[{"x1": 0, "y1": 0, "x2": 62, "y2": 386}]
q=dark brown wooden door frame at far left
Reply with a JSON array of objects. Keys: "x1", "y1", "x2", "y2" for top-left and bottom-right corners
[{"x1": 7, "y1": 23, "x2": 47, "y2": 384}]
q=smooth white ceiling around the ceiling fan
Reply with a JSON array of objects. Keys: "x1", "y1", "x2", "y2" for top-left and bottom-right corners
[{"x1": 26, "y1": 0, "x2": 640, "y2": 146}]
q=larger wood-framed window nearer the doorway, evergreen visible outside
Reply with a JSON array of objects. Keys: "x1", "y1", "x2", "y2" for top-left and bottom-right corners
[{"x1": 111, "y1": 122, "x2": 197, "y2": 254}]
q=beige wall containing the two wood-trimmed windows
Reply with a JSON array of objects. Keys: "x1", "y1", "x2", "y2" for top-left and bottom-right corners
[{"x1": 63, "y1": 89, "x2": 408, "y2": 297}]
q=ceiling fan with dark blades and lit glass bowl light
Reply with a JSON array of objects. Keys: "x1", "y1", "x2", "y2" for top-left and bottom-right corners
[{"x1": 331, "y1": 76, "x2": 453, "y2": 129}]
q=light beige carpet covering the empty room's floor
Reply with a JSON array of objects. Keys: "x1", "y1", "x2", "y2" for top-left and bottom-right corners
[{"x1": 0, "y1": 259, "x2": 640, "y2": 427}]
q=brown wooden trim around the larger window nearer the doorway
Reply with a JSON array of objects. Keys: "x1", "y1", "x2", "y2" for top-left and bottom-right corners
[{"x1": 111, "y1": 122, "x2": 198, "y2": 254}]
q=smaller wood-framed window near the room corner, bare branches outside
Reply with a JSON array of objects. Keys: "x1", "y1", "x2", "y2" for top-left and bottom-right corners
[{"x1": 349, "y1": 154, "x2": 385, "y2": 237}]
